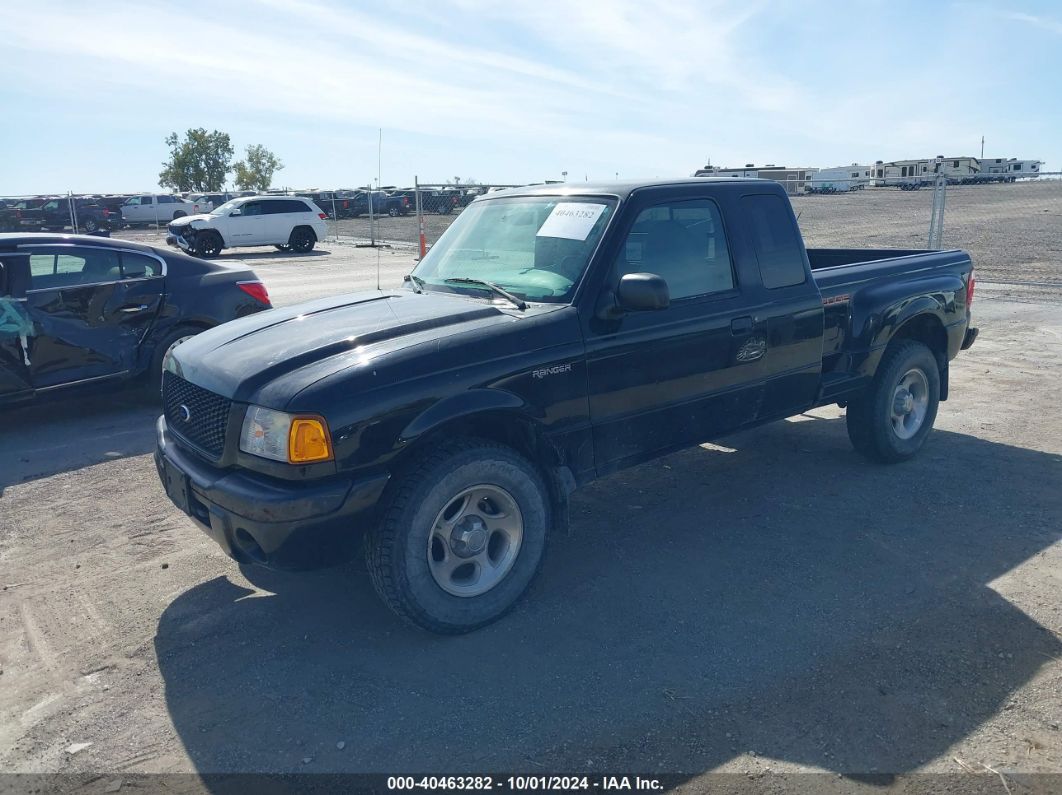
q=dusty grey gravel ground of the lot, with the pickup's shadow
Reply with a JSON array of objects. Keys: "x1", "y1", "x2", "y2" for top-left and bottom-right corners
[{"x1": 0, "y1": 209, "x2": 1062, "y2": 793}]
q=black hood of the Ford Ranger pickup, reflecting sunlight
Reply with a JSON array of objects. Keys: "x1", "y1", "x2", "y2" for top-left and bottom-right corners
[{"x1": 167, "y1": 290, "x2": 520, "y2": 410}]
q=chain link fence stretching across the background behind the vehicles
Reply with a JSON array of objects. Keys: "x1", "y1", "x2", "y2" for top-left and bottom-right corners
[{"x1": 0, "y1": 172, "x2": 1062, "y2": 287}]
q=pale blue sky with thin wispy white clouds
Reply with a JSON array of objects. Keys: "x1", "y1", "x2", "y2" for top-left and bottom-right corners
[{"x1": 0, "y1": 0, "x2": 1062, "y2": 195}]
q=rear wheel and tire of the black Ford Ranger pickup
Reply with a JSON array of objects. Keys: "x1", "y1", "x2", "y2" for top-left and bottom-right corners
[{"x1": 845, "y1": 340, "x2": 940, "y2": 464}]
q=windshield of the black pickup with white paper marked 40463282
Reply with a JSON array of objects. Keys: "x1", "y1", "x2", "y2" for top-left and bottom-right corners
[{"x1": 413, "y1": 196, "x2": 616, "y2": 303}]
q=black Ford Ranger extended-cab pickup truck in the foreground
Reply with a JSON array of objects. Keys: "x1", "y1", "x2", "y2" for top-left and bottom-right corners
[{"x1": 155, "y1": 178, "x2": 977, "y2": 633}]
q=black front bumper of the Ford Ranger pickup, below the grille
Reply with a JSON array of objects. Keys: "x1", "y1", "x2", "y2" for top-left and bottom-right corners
[{"x1": 155, "y1": 417, "x2": 389, "y2": 569}]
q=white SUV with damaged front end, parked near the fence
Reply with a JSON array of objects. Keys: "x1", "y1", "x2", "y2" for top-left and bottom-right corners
[{"x1": 166, "y1": 196, "x2": 328, "y2": 257}]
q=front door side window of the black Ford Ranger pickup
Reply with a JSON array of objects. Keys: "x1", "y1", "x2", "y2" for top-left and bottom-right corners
[{"x1": 616, "y1": 198, "x2": 734, "y2": 300}]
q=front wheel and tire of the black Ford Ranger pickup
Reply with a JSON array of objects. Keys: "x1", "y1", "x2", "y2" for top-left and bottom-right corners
[{"x1": 365, "y1": 439, "x2": 550, "y2": 635}]
